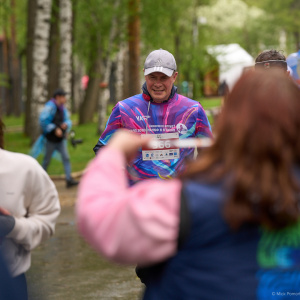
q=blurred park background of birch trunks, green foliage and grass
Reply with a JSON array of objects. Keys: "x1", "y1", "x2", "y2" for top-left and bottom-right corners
[{"x1": 0, "y1": 0, "x2": 300, "y2": 175}]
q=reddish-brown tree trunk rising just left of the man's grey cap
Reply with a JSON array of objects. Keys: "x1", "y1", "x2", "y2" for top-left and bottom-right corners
[{"x1": 128, "y1": 0, "x2": 141, "y2": 96}]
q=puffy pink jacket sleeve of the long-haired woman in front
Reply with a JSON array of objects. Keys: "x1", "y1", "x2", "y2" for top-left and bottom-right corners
[{"x1": 76, "y1": 145, "x2": 181, "y2": 265}]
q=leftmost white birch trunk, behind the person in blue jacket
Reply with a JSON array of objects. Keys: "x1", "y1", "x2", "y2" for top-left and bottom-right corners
[{"x1": 30, "y1": 0, "x2": 51, "y2": 142}]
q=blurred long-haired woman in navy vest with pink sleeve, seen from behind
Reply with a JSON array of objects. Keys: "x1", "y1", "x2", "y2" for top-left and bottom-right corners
[{"x1": 77, "y1": 70, "x2": 300, "y2": 300}]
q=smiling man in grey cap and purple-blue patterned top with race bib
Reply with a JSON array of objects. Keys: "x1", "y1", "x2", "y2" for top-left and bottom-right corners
[{"x1": 93, "y1": 49, "x2": 212, "y2": 184}]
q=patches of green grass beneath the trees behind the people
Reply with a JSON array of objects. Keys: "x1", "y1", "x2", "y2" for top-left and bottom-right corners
[{"x1": 3, "y1": 98, "x2": 221, "y2": 175}]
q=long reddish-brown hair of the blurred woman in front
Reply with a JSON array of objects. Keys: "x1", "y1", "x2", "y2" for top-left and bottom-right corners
[{"x1": 184, "y1": 71, "x2": 300, "y2": 228}]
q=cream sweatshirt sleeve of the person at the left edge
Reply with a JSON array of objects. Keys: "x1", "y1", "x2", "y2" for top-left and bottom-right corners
[{"x1": 6, "y1": 159, "x2": 61, "y2": 251}]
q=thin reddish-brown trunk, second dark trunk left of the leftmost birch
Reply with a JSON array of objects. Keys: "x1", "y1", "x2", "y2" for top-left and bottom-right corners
[{"x1": 10, "y1": 0, "x2": 22, "y2": 117}]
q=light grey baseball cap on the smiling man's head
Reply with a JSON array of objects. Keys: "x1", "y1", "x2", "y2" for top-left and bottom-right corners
[{"x1": 144, "y1": 49, "x2": 177, "y2": 77}]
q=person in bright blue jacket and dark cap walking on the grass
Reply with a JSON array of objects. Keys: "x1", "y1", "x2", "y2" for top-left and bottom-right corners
[{"x1": 39, "y1": 89, "x2": 78, "y2": 188}]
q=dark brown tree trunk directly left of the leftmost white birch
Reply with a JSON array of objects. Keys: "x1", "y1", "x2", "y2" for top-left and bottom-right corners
[{"x1": 24, "y1": 0, "x2": 37, "y2": 136}]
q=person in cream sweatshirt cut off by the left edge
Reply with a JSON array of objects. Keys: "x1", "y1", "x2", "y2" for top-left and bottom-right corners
[{"x1": 0, "y1": 116, "x2": 60, "y2": 300}]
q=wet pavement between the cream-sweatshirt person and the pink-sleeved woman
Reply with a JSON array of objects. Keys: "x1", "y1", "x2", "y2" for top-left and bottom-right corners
[{"x1": 26, "y1": 181, "x2": 143, "y2": 300}]
